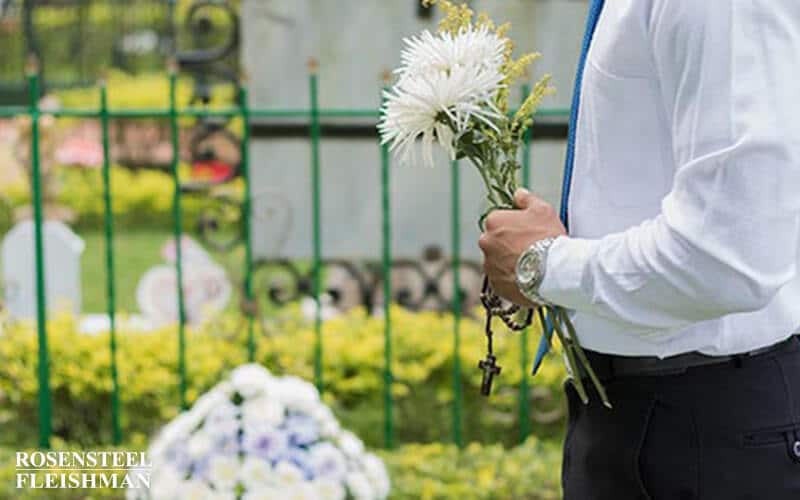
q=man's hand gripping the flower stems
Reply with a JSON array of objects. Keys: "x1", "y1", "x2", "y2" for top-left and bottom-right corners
[{"x1": 478, "y1": 188, "x2": 567, "y2": 306}]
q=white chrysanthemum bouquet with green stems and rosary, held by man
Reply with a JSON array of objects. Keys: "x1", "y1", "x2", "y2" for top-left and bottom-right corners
[{"x1": 378, "y1": 0, "x2": 610, "y2": 406}]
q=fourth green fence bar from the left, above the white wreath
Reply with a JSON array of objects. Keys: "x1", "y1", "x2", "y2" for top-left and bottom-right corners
[{"x1": 239, "y1": 84, "x2": 257, "y2": 363}]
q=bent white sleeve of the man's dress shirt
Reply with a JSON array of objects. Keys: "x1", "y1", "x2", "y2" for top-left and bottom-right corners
[{"x1": 540, "y1": 0, "x2": 800, "y2": 337}]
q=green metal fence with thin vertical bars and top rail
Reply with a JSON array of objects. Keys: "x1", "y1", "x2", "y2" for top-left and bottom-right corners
[{"x1": 0, "y1": 65, "x2": 567, "y2": 448}]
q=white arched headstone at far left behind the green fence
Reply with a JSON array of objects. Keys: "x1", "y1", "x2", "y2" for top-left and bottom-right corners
[{"x1": 3, "y1": 221, "x2": 84, "y2": 318}]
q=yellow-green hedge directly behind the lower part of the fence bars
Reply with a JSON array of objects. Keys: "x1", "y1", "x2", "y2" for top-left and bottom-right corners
[{"x1": 0, "y1": 306, "x2": 564, "y2": 446}]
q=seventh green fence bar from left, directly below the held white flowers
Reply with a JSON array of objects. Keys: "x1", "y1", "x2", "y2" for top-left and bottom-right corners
[{"x1": 450, "y1": 160, "x2": 464, "y2": 447}]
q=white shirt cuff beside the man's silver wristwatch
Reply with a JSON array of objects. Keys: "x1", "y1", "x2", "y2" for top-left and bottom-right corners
[{"x1": 539, "y1": 236, "x2": 599, "y2": 310}]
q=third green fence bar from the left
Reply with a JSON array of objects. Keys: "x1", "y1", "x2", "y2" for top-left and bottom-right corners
[{"x1": 169, "y1": 62, "x2": 187, "y2": 409}]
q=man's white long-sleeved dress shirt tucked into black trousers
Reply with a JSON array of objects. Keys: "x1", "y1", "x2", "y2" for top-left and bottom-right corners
[{"x1": 540, "y1": 0, "x2": 800, "y2": 357}]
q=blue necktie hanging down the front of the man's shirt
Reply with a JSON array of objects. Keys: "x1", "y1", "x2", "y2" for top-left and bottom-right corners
[{"x1": 533, "y1": 0, "x2": 605, "y2": 375}]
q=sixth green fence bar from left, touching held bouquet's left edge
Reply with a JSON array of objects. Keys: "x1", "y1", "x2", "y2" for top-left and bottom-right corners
[{"x1": 381, "y1": 77, "x2": 394, "y2": 449}]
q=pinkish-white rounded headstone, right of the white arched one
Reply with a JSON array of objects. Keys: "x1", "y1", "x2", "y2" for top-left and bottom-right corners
[{"x1": 136, "y1": 236, "x2": 233, "y2": 325}]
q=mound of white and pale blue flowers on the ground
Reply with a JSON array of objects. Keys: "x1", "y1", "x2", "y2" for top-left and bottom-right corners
[{"x1": 128, "y1": 364, "x2": 389, "y2": 500}]
